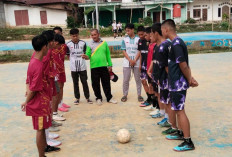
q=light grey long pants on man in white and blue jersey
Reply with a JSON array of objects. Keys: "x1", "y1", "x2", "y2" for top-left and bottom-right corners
[{"x1": 123, "y1": 67, "x2": 142, "y2": 96}]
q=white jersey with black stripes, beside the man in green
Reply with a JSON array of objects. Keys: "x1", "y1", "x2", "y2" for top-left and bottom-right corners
[{"x1": 67, "y1": 40, "x2": 86, "y2": 72}]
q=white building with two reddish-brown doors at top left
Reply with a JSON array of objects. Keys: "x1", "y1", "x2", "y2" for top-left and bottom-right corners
[{"x1": 0, "y1": 0, "x2": 79, "y2": 27}]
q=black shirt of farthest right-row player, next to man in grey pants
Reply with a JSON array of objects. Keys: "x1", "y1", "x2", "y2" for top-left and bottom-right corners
[{"x1": 138, "y1": 39, "x2": 149, "y2": 71}]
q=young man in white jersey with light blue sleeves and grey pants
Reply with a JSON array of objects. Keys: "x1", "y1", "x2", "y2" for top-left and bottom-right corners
[{"x1": 121, "y1": 23, "x2": 143, "y2": 102}]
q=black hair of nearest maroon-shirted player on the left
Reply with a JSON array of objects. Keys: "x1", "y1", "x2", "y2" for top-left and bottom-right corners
[{"x1": 31, "y1": 35, "x2": 48, "y2": 51}]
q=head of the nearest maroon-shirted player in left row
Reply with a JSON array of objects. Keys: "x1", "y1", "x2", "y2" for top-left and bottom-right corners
[{"x1": 32, "y1": 35, "x2": 48, "y2": 56}]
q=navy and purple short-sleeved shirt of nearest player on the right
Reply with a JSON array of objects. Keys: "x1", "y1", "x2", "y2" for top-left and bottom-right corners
[{"x1": 168, "y1": 37, "x2": 189, "y2": 91}]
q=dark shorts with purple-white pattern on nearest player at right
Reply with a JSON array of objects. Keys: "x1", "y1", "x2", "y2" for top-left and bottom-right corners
[{"x1": 170, "y1": 90, "x2": 187, "y2": 111}]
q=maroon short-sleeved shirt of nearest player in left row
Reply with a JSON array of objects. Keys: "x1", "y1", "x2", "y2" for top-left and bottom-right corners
[{"x1": 26, "y1": 57, "x2": 51, "y2": 116}]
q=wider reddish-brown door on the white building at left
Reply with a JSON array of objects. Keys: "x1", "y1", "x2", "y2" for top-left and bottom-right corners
[{"x1": 14, "y1": 10, "x2": 29, "y2": 26}]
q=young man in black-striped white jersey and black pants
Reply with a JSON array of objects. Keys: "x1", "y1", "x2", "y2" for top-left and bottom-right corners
[{"x1": 67, "y1": 28, "x2": 93, "y2": 105}]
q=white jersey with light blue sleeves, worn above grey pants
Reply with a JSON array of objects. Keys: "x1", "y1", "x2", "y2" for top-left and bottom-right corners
[{"x1": 121, "y1": 36, "x2": 140, "y2": 67}]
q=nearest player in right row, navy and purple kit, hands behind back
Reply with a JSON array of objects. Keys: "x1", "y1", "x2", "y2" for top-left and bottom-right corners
[{"x1": 161, "y1": 19, "x2": 198, "y2": 151}]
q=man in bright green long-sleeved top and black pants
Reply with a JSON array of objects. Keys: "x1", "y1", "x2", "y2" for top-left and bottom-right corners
[{"x1": 82, "y1": 29, "x2": 117, "y2": 105}]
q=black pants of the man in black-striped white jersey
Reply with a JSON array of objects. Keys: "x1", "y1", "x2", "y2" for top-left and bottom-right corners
[{"x1": 71, "y1": 70, "x2": 89, "y2": 99}]
